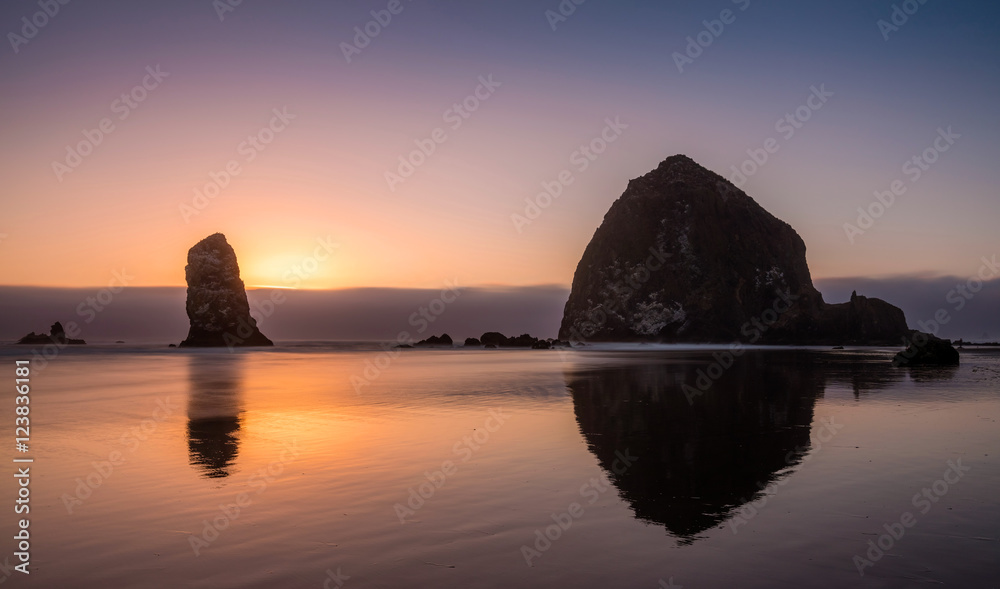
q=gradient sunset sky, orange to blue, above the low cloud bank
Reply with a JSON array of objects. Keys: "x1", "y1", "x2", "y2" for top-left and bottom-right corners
[{"x1": 0, "y1": 0, "x2": 1000, "y2": 288}]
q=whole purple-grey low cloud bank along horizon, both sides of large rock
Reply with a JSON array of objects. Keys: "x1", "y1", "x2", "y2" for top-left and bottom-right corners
[{"x1": 0, "y1": 277, "x2": 1000, "y2": 344}]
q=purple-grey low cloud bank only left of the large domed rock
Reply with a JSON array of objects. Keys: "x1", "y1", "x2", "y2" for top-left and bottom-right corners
[{"x1": 0, "y1": 286, "x2": 569, "y2": 343}]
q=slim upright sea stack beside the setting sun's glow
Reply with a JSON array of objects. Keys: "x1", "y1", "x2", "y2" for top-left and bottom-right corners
[{"x1": 181, "y1": 233, "x2": 274, "y2": 347}]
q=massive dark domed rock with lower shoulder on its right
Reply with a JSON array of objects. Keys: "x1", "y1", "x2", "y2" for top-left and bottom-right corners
[{"x1": 559, "y1": 155, "x2": 911, "y2": 345}]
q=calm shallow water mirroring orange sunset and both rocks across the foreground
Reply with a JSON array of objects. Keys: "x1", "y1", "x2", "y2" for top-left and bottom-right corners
[{"x1": 0, "y1": 345, "x2": 1000, "y2": 589}]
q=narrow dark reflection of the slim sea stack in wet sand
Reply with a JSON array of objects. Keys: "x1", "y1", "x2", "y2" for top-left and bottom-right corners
[{"x1": 188, "y1": 354, "x2": 243, "y2": 478}]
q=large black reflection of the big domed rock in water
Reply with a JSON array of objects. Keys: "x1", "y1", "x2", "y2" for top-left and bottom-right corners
[{"x1": 566, "y1": 350, "x2": 905, "y2": 543}]
